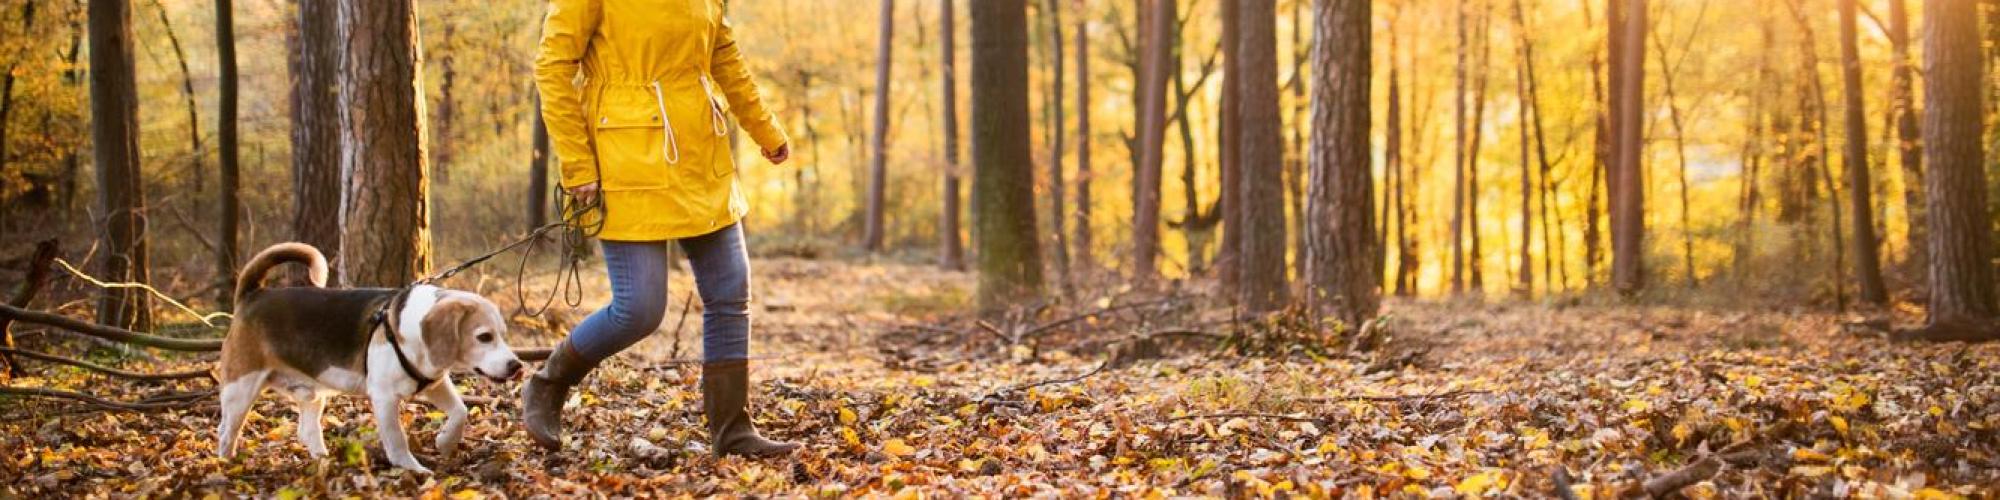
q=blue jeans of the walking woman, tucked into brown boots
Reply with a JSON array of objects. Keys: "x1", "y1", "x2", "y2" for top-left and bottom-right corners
[{"x1": 570, "y1": 224, "x2": 750, "y2": 362}]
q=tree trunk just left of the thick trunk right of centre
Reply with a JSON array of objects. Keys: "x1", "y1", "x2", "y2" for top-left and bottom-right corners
[{"x1": 1236, "y1": 0, "x2": 1288, "y2": 312}]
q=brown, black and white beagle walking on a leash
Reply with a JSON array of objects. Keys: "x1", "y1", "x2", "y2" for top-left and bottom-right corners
[{"x1": 216, "y1": 242, "x2": 522, "y2": 474}]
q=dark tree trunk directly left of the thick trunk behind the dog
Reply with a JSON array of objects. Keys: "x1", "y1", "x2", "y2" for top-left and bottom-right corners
[{"x1": 288, "y1": 0, "x2": 346, "y2": 286}]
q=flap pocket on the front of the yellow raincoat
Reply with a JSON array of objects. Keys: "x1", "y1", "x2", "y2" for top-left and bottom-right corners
[{"x1": 592, "y1": 90, "x2": 678, "y2": 190}]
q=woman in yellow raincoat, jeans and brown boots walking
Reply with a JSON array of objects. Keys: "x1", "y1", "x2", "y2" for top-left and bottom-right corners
[{"x1": 520, "y1": 0, "x2": 798, "y2": 456}]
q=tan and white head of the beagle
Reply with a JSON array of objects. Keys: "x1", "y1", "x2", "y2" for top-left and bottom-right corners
[{"x1": 424, "y1": 290, "x2": 522, "y2": 380}]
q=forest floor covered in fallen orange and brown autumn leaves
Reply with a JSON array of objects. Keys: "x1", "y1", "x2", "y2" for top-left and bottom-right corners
[{"x1": 0, "y1": 258, "x2": 2000, "y2": 498}]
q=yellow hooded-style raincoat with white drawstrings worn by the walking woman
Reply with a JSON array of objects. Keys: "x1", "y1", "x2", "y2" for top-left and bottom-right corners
[{"x1": 534, "y1": 0, "x2": 786, "y2": 242}]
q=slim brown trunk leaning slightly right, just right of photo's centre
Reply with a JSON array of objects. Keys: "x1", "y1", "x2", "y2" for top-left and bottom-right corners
[{"x1": 1132, "y1": 0, "x2": 1180, "y2": 282}]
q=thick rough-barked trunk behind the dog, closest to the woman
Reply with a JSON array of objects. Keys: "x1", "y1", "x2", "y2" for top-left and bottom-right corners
[{"x1": 336, "y1": 0, "x2": 432, "y2": 286}]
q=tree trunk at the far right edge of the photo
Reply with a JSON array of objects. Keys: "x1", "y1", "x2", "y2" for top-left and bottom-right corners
[{"x1": 1924, "y1": 0, "x2": 1996, "y2": 326}]
